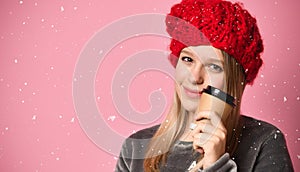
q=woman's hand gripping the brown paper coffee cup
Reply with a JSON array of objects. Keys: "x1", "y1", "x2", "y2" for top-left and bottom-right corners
[{"x1": 192, "y1": 111, "x2": 227, "y2": 169}]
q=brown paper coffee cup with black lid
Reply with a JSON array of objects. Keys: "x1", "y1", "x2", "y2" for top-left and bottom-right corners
[{"x1": 198, "y1": 86, "x2": 235, "y2": 120}]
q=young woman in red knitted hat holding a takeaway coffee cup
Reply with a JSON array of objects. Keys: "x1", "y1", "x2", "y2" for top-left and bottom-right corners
[{"x1": 116, "y1": 0, "x2": 293, "y2": 172}]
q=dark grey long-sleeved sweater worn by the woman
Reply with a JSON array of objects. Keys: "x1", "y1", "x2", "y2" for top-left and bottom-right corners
[{"x1": 116, "y1": 116, "x2": 294, "y2": 172}]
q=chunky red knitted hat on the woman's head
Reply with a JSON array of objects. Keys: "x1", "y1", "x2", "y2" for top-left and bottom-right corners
[{"x1": 166, "y1": 0, "x2": 263, "y2": 84}]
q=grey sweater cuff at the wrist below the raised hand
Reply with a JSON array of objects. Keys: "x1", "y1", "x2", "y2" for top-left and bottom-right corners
[{"x1": 199, "y1": 153, "x2": 237, "y2": 172}]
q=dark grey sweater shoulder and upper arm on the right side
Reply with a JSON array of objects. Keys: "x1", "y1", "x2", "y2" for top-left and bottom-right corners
[{"x1": 233, "y1": 116, "x2": 293, "y2": 171}]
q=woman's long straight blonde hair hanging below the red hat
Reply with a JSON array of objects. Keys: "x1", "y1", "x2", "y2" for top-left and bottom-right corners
[{"x1": 144, "y1": 51, "x2": 246, "y2": 172}]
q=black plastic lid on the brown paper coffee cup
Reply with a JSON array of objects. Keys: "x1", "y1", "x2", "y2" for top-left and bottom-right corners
[{"x1": 202, "y1": 85, "x2": 236, "y2": 107}]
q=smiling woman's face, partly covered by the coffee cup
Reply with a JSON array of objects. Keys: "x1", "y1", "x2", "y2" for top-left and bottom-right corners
[{"x1": 175, "y1": 45, "x2": 225, "y2": 113}]
